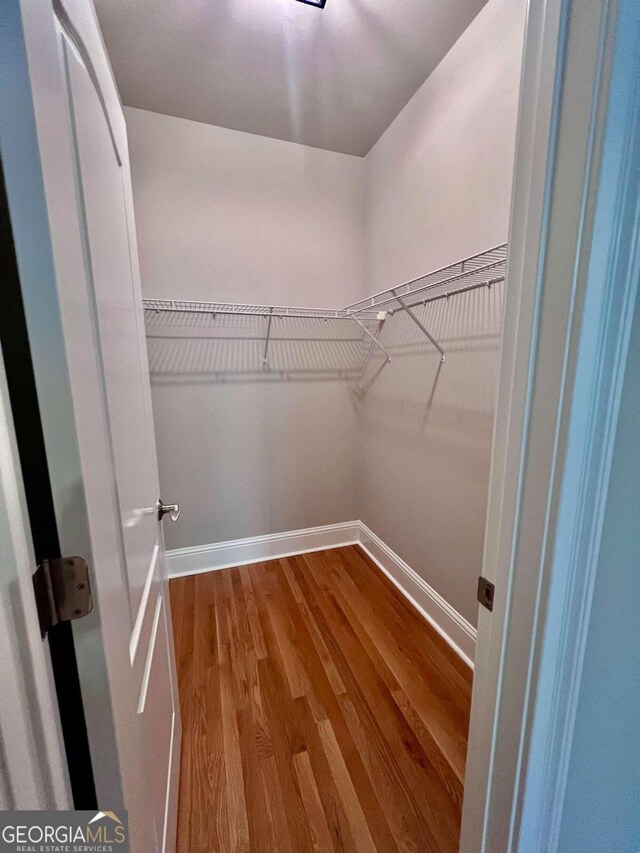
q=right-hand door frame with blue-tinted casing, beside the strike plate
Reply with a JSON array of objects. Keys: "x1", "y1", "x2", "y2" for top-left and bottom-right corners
[{"x1": 461, "y1": 0, "x2": 640, "y2": 853}]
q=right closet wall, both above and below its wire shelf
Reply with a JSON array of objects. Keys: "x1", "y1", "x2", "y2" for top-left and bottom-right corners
[{"x1": 359, "y1": 0, "x2": 525, "y2": 624}]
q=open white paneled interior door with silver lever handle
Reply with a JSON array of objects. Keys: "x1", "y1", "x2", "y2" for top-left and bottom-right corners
[{"x1": 2, "y1": 0, "x2": 180, "y2": 853}]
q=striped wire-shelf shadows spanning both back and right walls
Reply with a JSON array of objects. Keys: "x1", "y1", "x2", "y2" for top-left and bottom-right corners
[{"x1": 145, "y1": 283, "x2": 504, "y2": 408}]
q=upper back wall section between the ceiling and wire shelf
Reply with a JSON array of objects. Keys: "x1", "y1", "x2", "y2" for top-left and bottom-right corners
[{"x1": 125, "y1": 107, "x2": 364, "y2": 308}]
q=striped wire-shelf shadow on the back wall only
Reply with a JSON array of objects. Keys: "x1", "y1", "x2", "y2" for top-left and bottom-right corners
[{"x1": 145, "y1": 311, "x2": 380, "y2": 384}]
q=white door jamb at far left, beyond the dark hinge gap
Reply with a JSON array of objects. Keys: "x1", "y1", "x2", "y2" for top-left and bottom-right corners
[{"x1": 0, "y1": 348, "x2": 72, "y2": 811}]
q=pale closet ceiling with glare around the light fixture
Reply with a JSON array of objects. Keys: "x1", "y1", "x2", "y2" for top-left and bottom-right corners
[{"x1": 96, "y1": 0, "x2": 486, "y2": 156}]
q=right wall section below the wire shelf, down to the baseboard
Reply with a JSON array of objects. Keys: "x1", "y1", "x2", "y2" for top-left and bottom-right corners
[{"x1": 353, "y1": 284, "x2": 504, "y2": 624}]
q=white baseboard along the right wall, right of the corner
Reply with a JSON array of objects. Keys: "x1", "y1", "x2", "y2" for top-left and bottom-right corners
[{"x1": 360, "y1": 522, "x2": 477, "y2": 669}]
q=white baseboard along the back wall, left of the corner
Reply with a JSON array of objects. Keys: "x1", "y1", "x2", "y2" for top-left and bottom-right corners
[{"x1": 167, "y1": 521, "x2": 360, "y2": 578}]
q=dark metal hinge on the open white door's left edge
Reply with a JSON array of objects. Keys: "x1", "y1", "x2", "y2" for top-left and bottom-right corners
[{"x1": 33, "y1": 557, "x2": 93, "y2": 639}]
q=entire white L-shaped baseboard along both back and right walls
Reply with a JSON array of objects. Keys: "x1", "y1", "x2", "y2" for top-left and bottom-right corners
[{"x1": 167, "y1": 521, "x2": 476, "y2": 668}]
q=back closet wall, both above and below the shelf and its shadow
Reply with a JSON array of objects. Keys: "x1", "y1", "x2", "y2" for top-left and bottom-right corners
[{"x1": 125, "y1": 109, "x2": 364, "y2": 548}]
